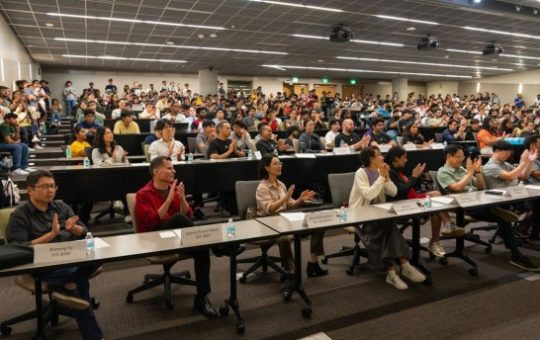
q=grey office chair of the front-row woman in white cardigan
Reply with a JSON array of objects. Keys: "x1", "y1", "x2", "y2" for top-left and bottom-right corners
[{"x1": 322, "y1": 172, "x2": 368, "y2": 275}]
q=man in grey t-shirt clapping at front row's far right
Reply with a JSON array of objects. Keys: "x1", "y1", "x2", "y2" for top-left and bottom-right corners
[{"x1": 483, "y1": 140, "x2": 537, "y2": 189}]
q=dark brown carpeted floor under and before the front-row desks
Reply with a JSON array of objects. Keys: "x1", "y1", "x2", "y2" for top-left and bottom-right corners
[{"x1": 0, "y1": 224, "x2": 540, "y2": 340}]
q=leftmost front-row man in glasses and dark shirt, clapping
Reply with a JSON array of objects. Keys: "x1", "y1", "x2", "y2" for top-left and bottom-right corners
[{"x1": 7, "y1": 170, "x2": 103, "y2": 340}]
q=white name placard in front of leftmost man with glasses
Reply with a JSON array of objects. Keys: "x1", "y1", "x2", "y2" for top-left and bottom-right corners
[{"x1": 34, "y1": 240, "x2": 86, "y2": 263}]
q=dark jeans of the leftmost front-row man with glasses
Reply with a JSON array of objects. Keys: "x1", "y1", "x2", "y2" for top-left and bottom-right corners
[{"x1": 43, "y1": 265, "x2": 103, "y2": 340}]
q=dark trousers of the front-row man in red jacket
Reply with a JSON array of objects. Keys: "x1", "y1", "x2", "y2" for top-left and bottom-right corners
[{"x1": 159, "y1": 213, "x2": 210, "y2": 297}]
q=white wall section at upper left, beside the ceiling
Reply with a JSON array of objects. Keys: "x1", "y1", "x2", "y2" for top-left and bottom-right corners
[{"x1": 0, "y1": 16, "x2": 41, "y2": 87}]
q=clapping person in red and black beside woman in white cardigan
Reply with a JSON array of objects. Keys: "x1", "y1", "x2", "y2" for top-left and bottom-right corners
[{"x1": 385, "y1": 146, "x2": 465, "y2": 257}]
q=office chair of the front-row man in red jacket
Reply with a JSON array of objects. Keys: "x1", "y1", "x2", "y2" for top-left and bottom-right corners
[{"x1": 126, "y1": 194, "x2": 195, "y2": 309}]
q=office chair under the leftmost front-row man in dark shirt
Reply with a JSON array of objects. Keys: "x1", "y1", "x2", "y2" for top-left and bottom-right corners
[{"x1": 0, "y1": 208, "x2": 103, "y2": 335}]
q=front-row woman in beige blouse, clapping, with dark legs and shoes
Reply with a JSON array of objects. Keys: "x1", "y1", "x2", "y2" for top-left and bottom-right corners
[{"x1": 256, "y1": 153, "x2": 328, "y2": 300}]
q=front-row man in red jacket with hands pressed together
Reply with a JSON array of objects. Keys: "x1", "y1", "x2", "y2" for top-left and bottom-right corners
[{"x1": 135, "y1": 156, "x2": 217, "y2": 318}]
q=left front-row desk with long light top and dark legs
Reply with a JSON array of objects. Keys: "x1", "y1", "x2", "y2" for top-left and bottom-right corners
[{"x1": 0, "y1": 220, "x2": 278, "y2": 339}]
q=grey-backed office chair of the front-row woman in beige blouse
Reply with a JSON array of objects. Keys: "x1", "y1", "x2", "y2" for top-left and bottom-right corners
[{"x1": 234, "y1": 181, "x2": 285, "y2": 283}]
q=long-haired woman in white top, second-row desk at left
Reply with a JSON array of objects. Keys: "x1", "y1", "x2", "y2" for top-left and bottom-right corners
[{"x1": 92, "y1": 127, "x2": 129, "y2": 166}]
